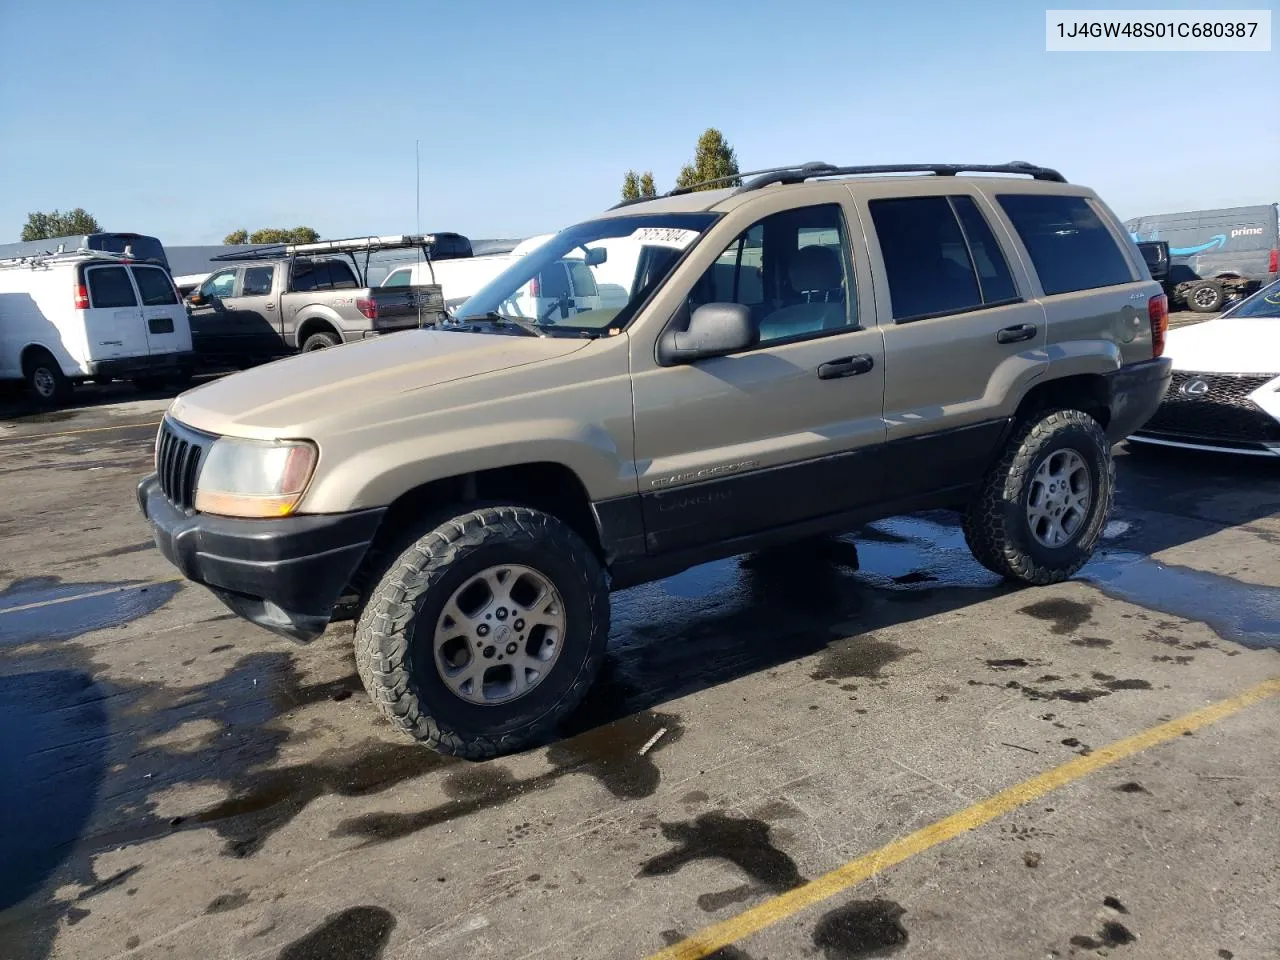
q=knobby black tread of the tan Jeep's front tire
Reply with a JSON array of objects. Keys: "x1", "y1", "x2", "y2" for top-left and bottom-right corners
[{"x1": 355, "y1": 504, "x2": 609, "y2": 760}]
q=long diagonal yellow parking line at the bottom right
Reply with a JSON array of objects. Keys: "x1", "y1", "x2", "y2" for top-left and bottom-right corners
[{"x1": 649, "y1": 677, "x2": 1280, "y2": 960}]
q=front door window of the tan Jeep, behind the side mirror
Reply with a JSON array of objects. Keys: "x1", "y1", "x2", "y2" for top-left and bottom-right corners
[{"x1": 689, "y1": 204, "x2": 858, "y2": 346}]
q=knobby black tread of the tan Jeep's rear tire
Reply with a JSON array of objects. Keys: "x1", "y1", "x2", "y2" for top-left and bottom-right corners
[{"x1": 964, "y1": 410, "x2": 1115, "y2": 586}]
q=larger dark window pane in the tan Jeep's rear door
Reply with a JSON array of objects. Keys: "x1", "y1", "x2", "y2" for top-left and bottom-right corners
[{"x1": 869, "y1": 197, "x2": 982, "y2": 321}]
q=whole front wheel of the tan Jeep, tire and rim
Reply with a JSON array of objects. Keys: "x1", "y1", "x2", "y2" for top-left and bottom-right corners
[{"x1": 356, "y1": 504, "x2": 609, "y2": 759}]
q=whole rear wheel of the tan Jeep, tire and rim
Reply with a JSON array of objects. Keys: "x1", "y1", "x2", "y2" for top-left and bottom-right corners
[{"x1": 964, "y1": 410, "x2": 1115, "y2": 585}]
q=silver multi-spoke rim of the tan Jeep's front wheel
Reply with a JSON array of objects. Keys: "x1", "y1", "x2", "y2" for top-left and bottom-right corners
[{"x1": 434, "y1": 564, "x2": 564, "y2": 707}]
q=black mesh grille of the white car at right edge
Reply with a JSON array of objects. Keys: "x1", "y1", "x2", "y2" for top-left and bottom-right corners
[{"x1": 1139, "y1": 370, "x2": 1280, "y2": 443}]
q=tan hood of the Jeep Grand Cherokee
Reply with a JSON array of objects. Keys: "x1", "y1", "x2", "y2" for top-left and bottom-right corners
[{"x1": 169, "y1": 330, "x2": 590, "y2": 439}]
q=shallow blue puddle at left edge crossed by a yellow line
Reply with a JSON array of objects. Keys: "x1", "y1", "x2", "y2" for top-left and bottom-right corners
[{"x1": 0, "y1": 577, "x2": 179, "y2": 644}]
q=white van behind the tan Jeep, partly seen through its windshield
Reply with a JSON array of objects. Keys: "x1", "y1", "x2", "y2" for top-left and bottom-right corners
[{"x1": 381, "y1": 252, "x2": 600, "y2": 321}]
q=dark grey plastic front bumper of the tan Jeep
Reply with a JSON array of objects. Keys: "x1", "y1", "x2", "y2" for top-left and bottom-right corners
[{"x1": 137, "y1": 475, "x2": 387, "y2": 643}]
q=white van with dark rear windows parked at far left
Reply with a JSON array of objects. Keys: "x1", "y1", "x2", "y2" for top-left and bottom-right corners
[{"x1": 0, "y1": 250, "x2": 195, "y2": 404}]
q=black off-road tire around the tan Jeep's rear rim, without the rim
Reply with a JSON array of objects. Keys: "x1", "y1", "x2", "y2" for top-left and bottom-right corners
[{"x1": 964, "y1": 410, "x2": 1115, "y2": 586}]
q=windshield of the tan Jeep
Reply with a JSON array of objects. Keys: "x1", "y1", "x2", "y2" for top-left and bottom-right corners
[{"x1": 453, "y1": 212, "x2": 718, "y2": 335}]
